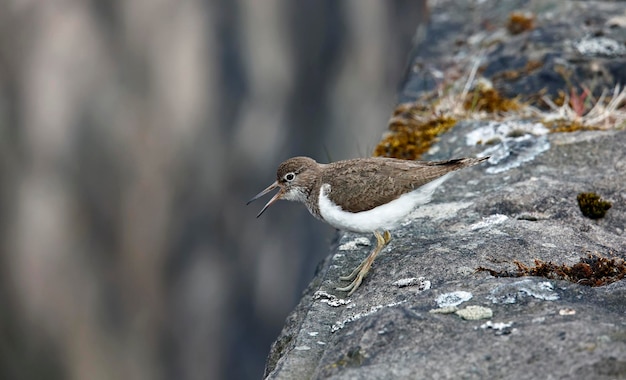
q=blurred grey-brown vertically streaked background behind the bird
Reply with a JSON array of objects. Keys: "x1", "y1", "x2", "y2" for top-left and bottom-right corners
[{"x1": 0, "y1": 0, "x2": 427, "y2": 379}]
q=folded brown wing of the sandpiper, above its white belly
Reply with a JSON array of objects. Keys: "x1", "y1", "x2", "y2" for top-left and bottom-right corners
[{"x1": 322, "y1": 158, "x2": 486, "y2": 212}]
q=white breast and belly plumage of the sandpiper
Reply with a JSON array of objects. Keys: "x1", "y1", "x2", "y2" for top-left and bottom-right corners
[{"x1": 319, "y1": 173, "x2": 453, "y2": 233}]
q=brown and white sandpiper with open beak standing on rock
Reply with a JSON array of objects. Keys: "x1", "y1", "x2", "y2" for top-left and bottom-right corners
[{"x1": 248, "y1": 157, "x2": 489, "y2": 296}]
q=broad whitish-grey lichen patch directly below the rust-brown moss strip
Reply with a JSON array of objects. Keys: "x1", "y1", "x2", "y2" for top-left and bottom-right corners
[{"x1": 487, "y1": 279, "x2": 559, "y2": 304}]
